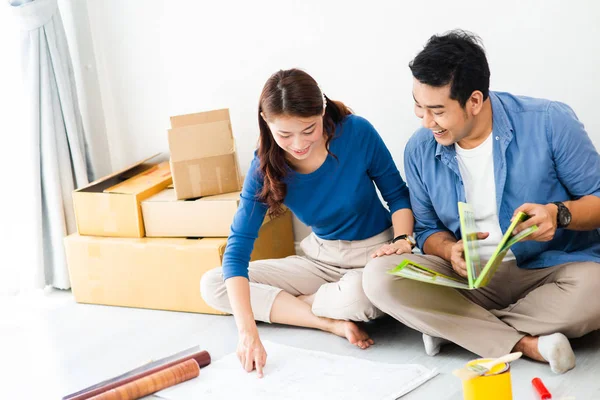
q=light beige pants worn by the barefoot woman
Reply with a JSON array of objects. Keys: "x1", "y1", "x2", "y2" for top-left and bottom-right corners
[{"x1": 200, "y1": 228, "x2": 393, "y2": 322}]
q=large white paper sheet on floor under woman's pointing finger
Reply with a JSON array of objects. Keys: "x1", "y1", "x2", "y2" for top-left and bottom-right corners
[{"x1": 155, "y1": 341, "x2": 437, "y2": 400}]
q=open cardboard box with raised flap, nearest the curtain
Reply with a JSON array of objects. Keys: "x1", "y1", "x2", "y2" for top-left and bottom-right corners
[{"x1": 73, "y1": 154, "x2": 173, "y2": 237}]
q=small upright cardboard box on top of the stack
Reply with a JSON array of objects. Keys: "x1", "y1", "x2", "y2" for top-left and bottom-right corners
[{"x1": 168, "y1": 109, "x2": 241, "y2": 200}]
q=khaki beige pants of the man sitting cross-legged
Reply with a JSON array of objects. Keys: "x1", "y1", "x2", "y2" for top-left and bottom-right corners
[{"x1": 363, "y1": 254, "x2": 600, "y2": 357}]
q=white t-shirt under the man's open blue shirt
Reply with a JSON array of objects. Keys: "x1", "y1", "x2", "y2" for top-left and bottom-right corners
[{"x1": 454, "y1": 132, "x2": 515, "y2": 261}]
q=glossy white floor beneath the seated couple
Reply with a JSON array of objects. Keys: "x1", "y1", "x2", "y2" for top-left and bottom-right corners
[{"x1": 0, "y1": 291, "x2": 600, "y2": 400}]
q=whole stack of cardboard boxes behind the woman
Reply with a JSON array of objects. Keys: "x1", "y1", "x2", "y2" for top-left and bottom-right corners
[{"x1": 65, "y1": 110, "x2": 294, "y2": 314}]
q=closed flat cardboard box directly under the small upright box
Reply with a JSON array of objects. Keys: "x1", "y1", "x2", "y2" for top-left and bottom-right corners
[{"x1": 142, "y1": 189, "x2": 240, "y2": 237}]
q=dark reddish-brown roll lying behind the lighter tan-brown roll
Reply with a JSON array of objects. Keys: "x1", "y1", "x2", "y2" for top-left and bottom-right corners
[{"x1": 62, "y1": 346, "x2": 210, "y2": 400}]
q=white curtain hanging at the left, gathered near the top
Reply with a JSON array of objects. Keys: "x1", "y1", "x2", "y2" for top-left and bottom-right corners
[{"x1": 9, "y1": 0, "x2": 93, "y2": 291}]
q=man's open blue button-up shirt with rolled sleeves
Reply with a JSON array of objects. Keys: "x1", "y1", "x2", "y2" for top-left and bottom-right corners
[{"x1": 404, "y1": 92, "x2": 600, "y2": 268}]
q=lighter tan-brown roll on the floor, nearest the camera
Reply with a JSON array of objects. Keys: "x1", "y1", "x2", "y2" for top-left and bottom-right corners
[{"x1": 90, "y1": 359, "x2": 200, "y2": 400}]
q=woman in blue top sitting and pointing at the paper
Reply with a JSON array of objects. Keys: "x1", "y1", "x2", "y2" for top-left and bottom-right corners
[{"x1": 201, "y1": 69, "x2": 413, "y2": 377}]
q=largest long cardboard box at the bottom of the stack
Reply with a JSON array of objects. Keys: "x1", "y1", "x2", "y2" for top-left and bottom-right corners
[{"x1": 65, "y1": 211, "x2": 294, "y2": 314}]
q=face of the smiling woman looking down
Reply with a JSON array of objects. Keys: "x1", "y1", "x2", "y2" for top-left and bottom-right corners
[{"x1": 263, "y1": 115, "x2": 325, "y2": 163}]
